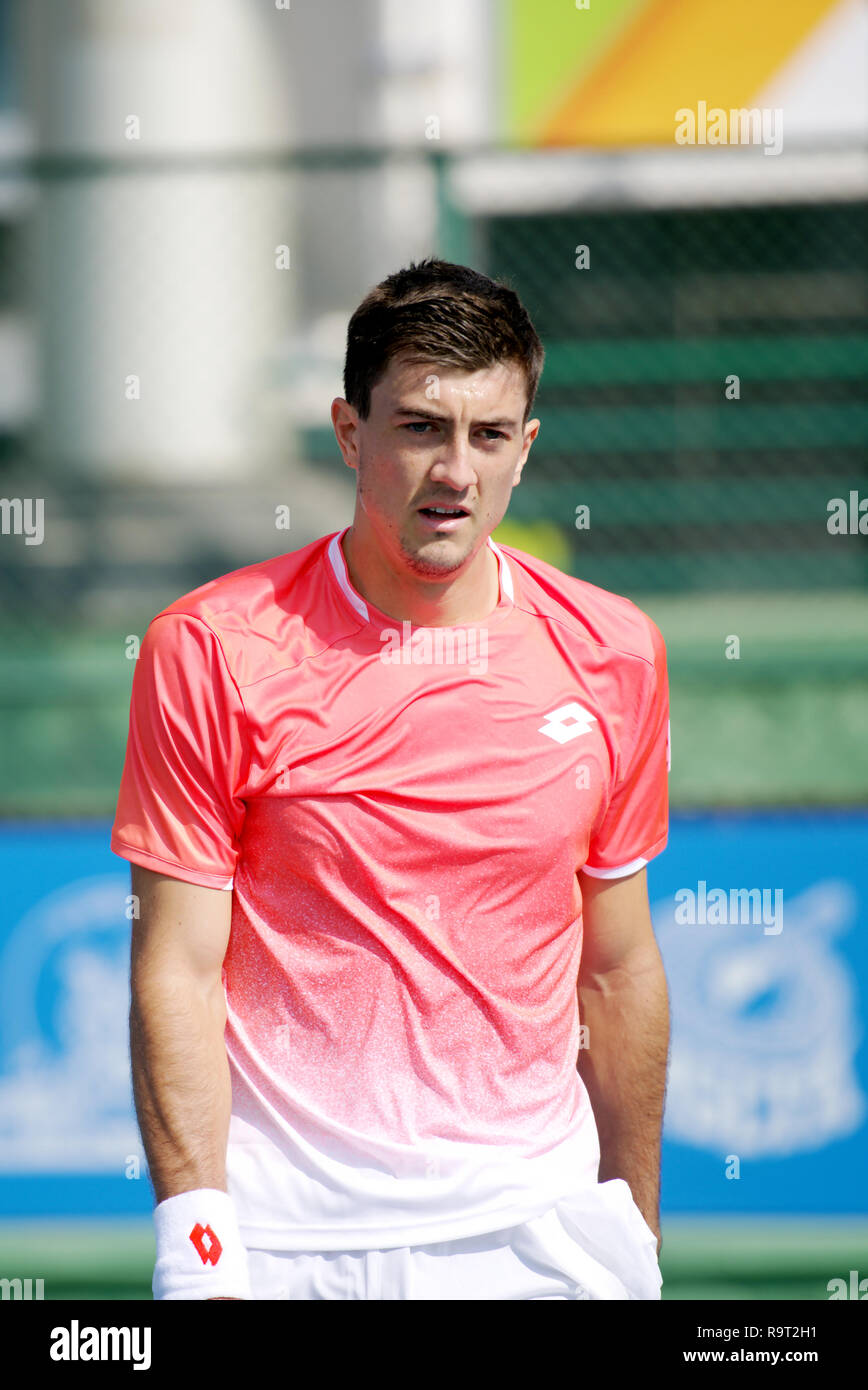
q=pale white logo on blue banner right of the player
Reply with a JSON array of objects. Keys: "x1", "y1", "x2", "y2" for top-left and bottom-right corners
[{"x1": 652, "y1": 880, "x2": 865, "y2": 1158}]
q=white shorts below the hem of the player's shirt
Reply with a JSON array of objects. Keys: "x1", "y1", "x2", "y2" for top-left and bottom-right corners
[{"x1": 240, "y1": 1179, "x2": 662, "y2": 1300}]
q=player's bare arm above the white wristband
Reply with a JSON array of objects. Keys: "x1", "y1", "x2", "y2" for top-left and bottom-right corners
[{"x1": 129, "y1": 865, "x2": 232, "y2": 1202}]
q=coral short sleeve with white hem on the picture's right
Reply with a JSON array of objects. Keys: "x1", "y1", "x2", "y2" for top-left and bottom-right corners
[{"x1": 581, "y1": 617, "x2": 670, "y2": 878}]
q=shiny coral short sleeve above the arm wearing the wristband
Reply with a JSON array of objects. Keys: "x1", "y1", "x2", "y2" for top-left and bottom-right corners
[{"x1": 111, "y1": 612, "x2": 246, "y2": 888}]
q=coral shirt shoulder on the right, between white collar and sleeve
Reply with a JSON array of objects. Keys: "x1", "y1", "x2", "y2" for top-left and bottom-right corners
[{"x1": 498, "y1": 545, "x2": 666, "y2": 666}]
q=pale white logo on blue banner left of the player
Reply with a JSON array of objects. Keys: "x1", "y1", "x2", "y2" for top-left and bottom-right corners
[{"x1": 0, "y1": 874, "x2": 140, "y2": 1172}]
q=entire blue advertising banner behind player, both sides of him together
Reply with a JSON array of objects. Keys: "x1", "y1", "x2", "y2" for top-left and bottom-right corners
[{"x1": 0, "y1": 812, "x2": 868, "y2": 1216}]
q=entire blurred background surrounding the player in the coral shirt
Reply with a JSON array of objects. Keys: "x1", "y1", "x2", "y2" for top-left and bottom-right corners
[{"x1": 0, "y1": 0, "x2": 868, "y2": 1300}]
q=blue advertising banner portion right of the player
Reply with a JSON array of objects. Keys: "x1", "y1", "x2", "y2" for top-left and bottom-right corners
[{"x1": 648, "y1": 812, "x2": 868, "y2": 1213}]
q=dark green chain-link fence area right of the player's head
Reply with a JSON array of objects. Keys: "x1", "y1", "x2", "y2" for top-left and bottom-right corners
[{"x1": 483, "y1": 195, "x2": 868, "y2": 594}]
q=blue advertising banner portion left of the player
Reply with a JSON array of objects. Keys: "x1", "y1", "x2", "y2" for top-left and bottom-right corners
[{"x1": 0, "y1": 824, "x2": 152, "y2": 1216}]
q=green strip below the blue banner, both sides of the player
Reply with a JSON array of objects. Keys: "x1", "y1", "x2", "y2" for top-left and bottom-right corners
[{"x1": 0, "y1": 1216, "x2": 868, "y2": 1302}]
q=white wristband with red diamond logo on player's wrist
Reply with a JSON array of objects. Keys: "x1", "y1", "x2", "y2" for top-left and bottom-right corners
[{"x1": 153, "y1": 1187, "x2": 253, "y2": 1298}]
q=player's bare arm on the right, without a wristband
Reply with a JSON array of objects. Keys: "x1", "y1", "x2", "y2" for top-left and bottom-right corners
[{"x1": 577, "y1": 869, "x2": 669, "y2": 1254}]
